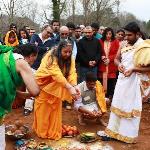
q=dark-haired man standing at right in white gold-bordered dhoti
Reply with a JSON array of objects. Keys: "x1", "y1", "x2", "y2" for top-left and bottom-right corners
[{"x1": 98, "y1": 22, "x2": 150, "y2": 143}]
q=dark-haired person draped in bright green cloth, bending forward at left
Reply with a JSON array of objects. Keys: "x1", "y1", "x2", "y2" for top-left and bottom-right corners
[{"x1": 0, "y1": 44, "x2": 39, "y2": 150}]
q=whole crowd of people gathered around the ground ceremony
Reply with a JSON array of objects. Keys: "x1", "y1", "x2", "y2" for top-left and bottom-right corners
[{"x1": 0, "y1": 20, "x2": 150, "y2": 150}]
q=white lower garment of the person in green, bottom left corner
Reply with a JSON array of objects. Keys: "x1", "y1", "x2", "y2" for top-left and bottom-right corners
[{"x1": 0, "y1": 124, "x2": 6, "y2": 150}]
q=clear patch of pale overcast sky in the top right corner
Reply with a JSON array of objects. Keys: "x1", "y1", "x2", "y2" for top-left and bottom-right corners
[{"x1": 120, "y1": 0, "x2": 150, "y2": 21}]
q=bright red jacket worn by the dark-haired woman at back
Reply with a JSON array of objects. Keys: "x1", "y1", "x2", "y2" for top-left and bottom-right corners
[{"x1": 98, "y1": 39, "x2": 119, "y2": 78}]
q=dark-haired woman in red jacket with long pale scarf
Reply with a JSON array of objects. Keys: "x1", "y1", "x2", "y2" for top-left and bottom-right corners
[{"x1": 98, "y1": 28, "x2": 119, "y2": 99}]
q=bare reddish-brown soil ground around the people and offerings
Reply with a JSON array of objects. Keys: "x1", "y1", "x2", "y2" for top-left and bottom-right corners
[{"x1": 5, "y1": 104, "x2": 150, "y2": 150}]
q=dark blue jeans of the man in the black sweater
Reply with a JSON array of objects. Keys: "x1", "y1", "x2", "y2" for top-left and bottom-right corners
[{"x1": 79, "y1": 66, "x2": 97, "y2": 83}]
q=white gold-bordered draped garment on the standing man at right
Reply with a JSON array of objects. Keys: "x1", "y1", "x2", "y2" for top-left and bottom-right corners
[{"x1": 105, "y1": 39, "x2": 145, "y2": 143}]
